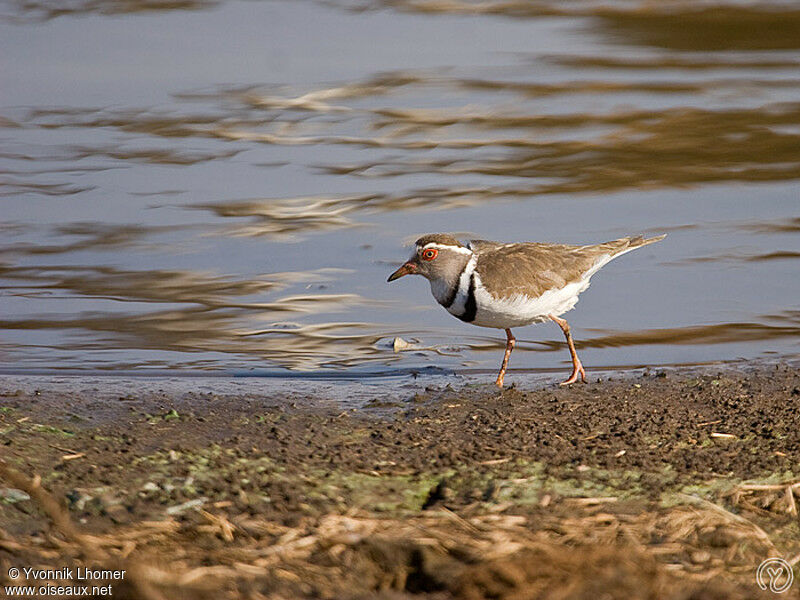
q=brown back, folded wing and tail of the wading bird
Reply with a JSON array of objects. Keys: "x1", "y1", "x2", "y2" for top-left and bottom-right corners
[{"x1": 470, "y1": 236, "x2": 662, "y2": 298}]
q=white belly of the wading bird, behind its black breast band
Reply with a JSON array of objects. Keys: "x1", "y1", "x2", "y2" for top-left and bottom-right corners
[{"x1": 472, "y1": 278, "x2": 589, "y2": 329}]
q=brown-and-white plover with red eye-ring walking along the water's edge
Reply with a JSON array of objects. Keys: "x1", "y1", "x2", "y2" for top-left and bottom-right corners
[{"x1": 387, "y1": 233, "x2": 666, "y2": 389}]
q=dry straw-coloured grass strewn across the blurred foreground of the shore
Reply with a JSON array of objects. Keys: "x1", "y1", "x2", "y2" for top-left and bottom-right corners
[{"x1": 0, "y1": 460, "x2": 798, "y2": 600}]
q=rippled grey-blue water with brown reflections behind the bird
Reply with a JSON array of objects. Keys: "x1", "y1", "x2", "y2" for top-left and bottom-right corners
[{"x1": 0, "y1": 0, "x2": 800, "y2": 374}]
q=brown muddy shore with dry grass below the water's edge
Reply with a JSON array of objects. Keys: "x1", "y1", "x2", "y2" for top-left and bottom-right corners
[{"x1": 0, "y1": 365, "x2": 800, "y2": 600}]
